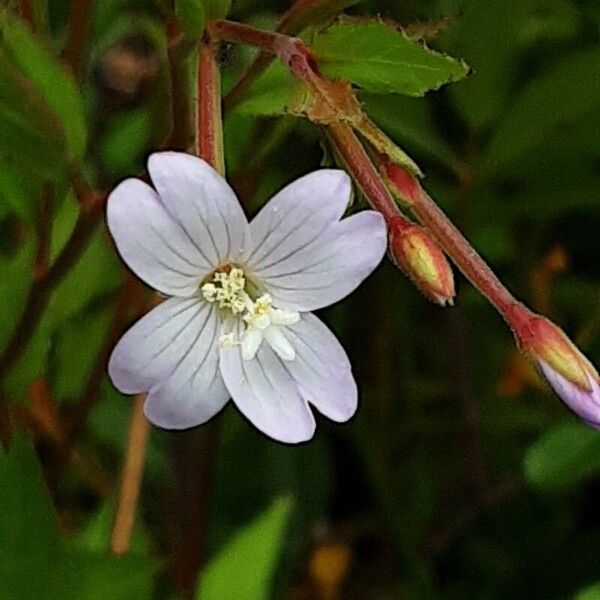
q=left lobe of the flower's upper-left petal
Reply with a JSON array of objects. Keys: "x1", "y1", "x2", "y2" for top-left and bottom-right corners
[{"x1": 107, "y1": 179, "x2": 212, "y2": 296}]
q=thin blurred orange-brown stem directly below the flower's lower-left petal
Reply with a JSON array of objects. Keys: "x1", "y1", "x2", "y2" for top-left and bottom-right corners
[{"x1": 110, "y1": 394, "x2": 150, "y2": 555}]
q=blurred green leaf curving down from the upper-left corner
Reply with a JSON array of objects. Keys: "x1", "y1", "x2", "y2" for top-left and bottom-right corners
[{"x1": 0, "y1": 10, "x2": 86, "y2": 161}]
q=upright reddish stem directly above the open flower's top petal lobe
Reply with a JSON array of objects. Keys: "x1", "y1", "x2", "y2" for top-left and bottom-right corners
[{"x1": 196, "y1": 42, "x2": 225, "y2": 175}]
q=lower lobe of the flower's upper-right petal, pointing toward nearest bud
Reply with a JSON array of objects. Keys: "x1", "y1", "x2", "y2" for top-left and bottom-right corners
[{"x1": 252, "y1": 211, "x2": 387, "y2": 312}]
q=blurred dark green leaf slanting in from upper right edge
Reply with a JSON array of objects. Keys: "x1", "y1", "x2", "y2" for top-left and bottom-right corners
[{"x1": 486, "y1": 49, "x2": 600, "y2": 171}]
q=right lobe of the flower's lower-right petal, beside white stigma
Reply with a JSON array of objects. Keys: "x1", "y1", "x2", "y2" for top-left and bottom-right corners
[{"x1": 285, "y1": 313, "x2": 358, "y2": 423}]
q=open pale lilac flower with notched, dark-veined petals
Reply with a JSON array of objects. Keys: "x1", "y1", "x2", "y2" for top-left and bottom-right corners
[{"x1": 107, "y1": 152, "x2": 386, "y2": 443}]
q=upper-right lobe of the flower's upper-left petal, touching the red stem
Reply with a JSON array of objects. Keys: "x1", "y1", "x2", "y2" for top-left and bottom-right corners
[{"x1": 148, "y1": 152, "x2": 251, "y2": 267}]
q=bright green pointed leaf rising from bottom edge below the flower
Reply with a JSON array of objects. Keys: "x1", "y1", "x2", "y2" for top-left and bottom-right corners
[{"x1": 196, "y1": 497, "x2": 292, "y2": 600}]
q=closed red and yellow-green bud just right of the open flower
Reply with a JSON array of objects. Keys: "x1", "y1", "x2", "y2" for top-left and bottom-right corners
[{"x1": 388, "y1": 216, "x2": 454, "y2": 306}]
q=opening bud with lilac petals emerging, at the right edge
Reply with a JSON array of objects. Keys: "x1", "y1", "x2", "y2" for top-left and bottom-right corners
[{"x1": 515, "y1": 314, "x2": 600, "y2": 428}]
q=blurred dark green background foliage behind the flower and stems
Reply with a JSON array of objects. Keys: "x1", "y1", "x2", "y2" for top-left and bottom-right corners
[{"x1": 0, "y1": 0, "x2": 600, "y2": 600}]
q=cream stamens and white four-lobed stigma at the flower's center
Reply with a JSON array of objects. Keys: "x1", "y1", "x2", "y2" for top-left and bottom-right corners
[{"x1": 200, "y1": 265, "x2": 300, "y2": 360}]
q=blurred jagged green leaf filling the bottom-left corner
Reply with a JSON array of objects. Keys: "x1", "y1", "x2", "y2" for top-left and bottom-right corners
[{"x1": 0, "y1": 436, "x2": 158, "y2": 600}]
